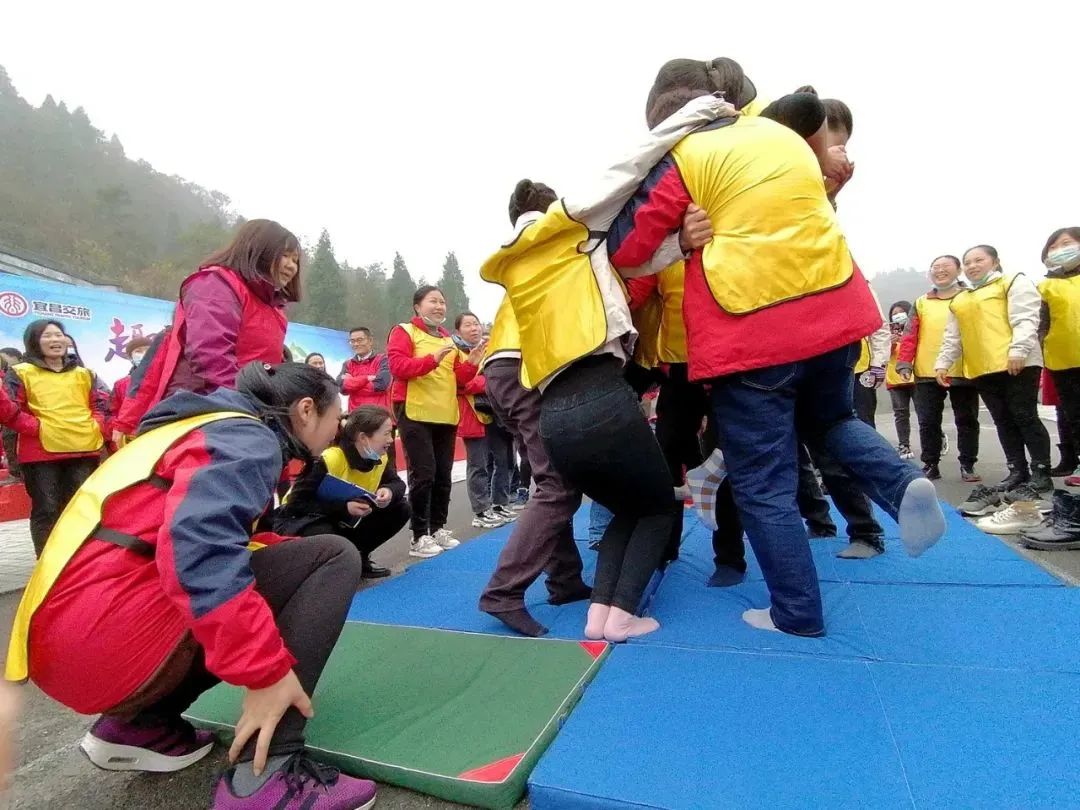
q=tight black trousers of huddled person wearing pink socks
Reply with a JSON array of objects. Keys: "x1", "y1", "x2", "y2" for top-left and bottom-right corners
[{"x1": 540, "y1": 355, "x2": 674, "y2": 613}]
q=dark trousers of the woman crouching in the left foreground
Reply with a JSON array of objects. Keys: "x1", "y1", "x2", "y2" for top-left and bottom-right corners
[{"x1": 125, "y1": 535, "x2": 362, "y2": 761}]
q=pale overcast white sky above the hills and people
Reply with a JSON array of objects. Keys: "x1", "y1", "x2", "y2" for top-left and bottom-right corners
[{"x1": 0, "y1": 0, "x2": 1080, "y2": 316}]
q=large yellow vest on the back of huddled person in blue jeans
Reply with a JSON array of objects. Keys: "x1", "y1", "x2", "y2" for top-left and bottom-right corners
[{"x1": 672, "y1": 116, "x2": 853, "y2": 314}]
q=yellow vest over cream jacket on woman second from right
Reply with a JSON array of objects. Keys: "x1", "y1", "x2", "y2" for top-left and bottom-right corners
[{"x1": 949, "y1": 274, "x2": 1016, "y2": 380}]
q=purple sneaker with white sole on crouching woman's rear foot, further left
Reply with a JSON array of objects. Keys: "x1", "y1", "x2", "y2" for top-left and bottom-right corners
[{"x1": 79, "y1": 715, "x2": 214, "y2": 773}]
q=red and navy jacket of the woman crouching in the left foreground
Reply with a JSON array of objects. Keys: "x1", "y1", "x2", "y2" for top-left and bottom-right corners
[{"x1": 30, "y1": 390, "x2": 296, "y2": 714}]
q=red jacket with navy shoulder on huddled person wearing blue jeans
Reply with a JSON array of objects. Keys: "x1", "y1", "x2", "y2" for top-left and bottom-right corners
[{"x1": 608, "y1": 156, "x2": 881, "y2": 380}]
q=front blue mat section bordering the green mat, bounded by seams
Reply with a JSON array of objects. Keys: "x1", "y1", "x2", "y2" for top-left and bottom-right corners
[{"x1": 529, "y1": 646, "x2": 912, "y2": 810}]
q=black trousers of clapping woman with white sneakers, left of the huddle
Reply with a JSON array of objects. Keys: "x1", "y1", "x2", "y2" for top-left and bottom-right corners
[{"x1": 395, "y1": 403, "x2": 458, "y2": 538}]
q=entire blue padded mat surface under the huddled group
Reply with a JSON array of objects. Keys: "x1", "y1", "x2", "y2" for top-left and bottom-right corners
[{"x1": 339, "y1": 504, "x2": 1080, "y2": 810}]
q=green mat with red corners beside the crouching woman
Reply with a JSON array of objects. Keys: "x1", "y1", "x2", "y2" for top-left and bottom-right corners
[{"x1": 186, "y1": 622, "x2": 608, "y2": 810}]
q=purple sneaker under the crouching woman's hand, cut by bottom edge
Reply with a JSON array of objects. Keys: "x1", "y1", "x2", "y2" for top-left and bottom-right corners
[{"x1": 211, "y1": 752, "x2": 376, "y2": 810}]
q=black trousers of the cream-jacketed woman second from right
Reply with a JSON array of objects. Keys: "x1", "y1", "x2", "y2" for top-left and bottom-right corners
[{"x1": 975, "y1": 366, "x2": 1050, "y2": 472}]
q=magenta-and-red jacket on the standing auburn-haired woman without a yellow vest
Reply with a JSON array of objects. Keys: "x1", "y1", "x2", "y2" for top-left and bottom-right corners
[{"x1": 112, "y1": 266, "x2": 288, "y2": 435}]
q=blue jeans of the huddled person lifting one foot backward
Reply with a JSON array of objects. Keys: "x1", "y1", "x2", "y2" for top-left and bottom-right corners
[{"x1": 713, "y1": 343, "x2": 922, "y2": 636}]
